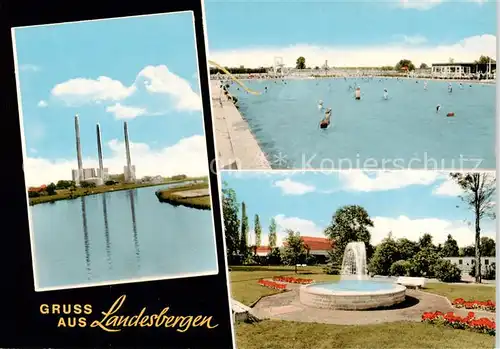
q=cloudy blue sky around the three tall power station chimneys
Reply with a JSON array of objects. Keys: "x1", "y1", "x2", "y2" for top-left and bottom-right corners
[{"x1": 14, "y1": 12, "x2": 208, "y2": 185}]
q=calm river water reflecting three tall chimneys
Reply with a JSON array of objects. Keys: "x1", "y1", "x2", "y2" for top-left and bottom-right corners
[{"x1": 30, "y1": 185, "x2": 217, "y2": 288}]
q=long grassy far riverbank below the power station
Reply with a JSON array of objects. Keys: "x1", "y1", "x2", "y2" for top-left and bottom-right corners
[{"x1": 29, "y1": 177, "x2": 206, "y2": 206}]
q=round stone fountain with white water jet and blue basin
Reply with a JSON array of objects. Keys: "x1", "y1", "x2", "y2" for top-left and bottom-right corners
[{"x1": 300, "y1": 242, "x2": 406, "y2": 310}]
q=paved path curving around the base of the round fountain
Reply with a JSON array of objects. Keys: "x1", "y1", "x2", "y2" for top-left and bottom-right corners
[{"x1": 253, "y1": 284, "x2": 495, "y2": 325}]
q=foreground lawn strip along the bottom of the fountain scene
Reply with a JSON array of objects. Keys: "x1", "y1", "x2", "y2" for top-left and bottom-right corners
[{"x1": 235, "y1": 320, "x2": 495, "y2": 349}]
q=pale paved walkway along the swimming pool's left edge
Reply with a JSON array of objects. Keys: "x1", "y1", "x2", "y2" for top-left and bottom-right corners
[{"x1": 211, "y1": 81, "x2": 271, "y2": 170}]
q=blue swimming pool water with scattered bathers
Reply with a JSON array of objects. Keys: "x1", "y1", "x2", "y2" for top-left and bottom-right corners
[{"x1": 230, "y1": 79, "x2": 496, "y2": 169}]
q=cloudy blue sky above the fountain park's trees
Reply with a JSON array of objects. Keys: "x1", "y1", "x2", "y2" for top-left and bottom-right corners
[{"x1": 222, "y1": 170, "x2": 495, "y2": 246}]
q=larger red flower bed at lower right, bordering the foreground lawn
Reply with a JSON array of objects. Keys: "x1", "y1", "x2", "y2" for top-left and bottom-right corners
[{"x1": 422, "y1": 311, "x2": 496, "y2": 336}]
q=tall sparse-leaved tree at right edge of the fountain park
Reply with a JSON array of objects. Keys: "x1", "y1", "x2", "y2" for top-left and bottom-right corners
[{"x1": 450, "y1": 172, "x2": 496, "y2": 283}]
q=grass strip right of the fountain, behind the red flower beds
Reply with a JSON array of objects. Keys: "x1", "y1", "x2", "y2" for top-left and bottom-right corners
[{"x1": 423, "y1": 283, "x2": 496, "y2": 302}]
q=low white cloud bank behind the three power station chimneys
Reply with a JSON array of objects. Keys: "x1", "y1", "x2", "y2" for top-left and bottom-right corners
[{"x1": 24, "y1": 135, "x2": 208, "y2": 186}]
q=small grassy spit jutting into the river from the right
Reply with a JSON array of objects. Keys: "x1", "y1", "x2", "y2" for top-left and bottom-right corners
[{"x1": 156, "y1": 182, "x2": 212, "y2": 210}]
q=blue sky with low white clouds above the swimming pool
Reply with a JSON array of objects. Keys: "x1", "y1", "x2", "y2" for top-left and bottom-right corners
[{"x1": 205, "y1": 0, "x2": 497, "y2": 67}]
